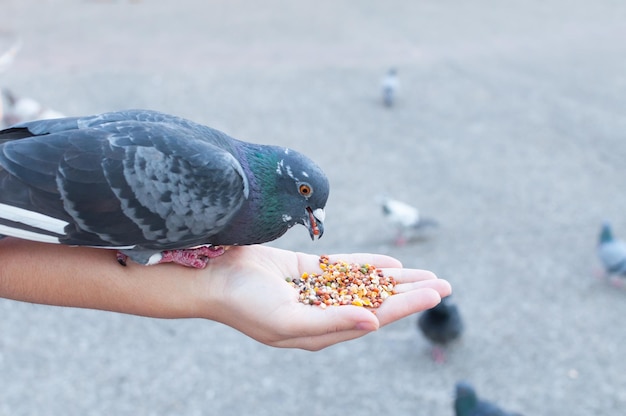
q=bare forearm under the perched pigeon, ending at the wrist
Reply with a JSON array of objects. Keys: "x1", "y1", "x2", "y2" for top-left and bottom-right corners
[{"x1": 0, "y1": 238, "x2": 206, "y2": 318}]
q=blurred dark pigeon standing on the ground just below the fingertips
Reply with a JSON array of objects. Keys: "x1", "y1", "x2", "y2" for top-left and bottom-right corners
[{"x1": 417, "y1": 296, "x2": 463, "y2": 364}]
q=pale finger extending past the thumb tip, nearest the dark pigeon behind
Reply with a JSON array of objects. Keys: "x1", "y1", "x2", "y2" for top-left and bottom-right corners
[{"x1": 376, "y1": 287, "x2": 441, "y2": 326}]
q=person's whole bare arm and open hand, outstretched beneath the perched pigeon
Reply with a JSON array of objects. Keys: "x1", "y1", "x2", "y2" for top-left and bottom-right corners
[{"x1": 0, "y1": 238, "x2": 451, "y2": 350}]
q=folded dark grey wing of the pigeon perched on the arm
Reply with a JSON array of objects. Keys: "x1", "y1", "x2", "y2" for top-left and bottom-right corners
[{"x1": 0, "y1": 115, "x2": 248, "y2": 249}]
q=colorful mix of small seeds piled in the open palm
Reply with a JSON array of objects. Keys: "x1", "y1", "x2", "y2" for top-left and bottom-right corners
[{"x1": 287, "y1": 256, "x2": 396, "y2": 308}]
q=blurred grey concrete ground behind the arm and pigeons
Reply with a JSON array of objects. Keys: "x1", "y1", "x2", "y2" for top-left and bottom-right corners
[{"x1": 0, "y1": 0, "x2": 626, "y2": 415}]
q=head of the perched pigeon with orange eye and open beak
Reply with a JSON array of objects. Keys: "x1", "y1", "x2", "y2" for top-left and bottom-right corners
[{"x1": 275, "y1": 149, "x2": 329, "y2": 240}]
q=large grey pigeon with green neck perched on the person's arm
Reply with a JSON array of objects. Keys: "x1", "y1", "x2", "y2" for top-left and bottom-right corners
[{"x1": 0, "y1": 110, "x2": 329, "y2": 268}]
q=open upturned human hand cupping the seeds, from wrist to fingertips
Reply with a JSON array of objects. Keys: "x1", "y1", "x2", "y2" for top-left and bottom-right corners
[{"x1": 199, "y1": 246, "x2": 451, "y2": 350}]
